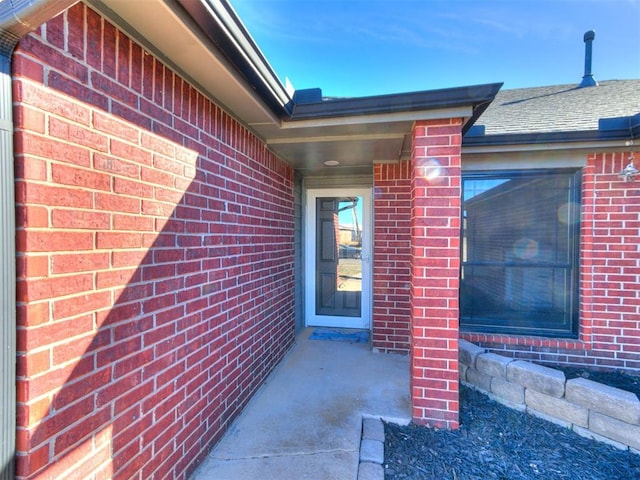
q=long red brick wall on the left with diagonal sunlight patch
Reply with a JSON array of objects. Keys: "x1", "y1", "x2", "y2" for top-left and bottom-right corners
[{"x1": 13, "y1": 4, "x2": 294, "y2": 479}]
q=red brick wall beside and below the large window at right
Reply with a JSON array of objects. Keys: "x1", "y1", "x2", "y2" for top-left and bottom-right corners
[{"x1": 463, "y1": 152, "x2": 640, "y2": 370}]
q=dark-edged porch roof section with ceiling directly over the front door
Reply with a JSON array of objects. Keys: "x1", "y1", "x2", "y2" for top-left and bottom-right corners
[{"x1": 262, "y1": 84, "x2": 502, "y2": 175}]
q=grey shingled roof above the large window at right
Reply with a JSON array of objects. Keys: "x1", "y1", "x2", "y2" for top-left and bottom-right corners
[{"x1": 465, "y1": 79, "x2": 640, "y2": 144}]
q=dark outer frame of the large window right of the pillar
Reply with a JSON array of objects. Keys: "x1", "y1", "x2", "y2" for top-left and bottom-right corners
[{"x1": 459, "y1": 168, "x2": 582, "y2": 339}]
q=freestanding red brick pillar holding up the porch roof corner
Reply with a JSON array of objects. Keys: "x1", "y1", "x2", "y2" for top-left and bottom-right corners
[{"x1": 410, "y1": 119, "x2": 462, "y2": 429}]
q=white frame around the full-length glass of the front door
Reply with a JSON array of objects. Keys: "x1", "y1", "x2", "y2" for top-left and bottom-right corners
[{"x1": 304, "y1": 187, "x2": 373, "y2": 329}]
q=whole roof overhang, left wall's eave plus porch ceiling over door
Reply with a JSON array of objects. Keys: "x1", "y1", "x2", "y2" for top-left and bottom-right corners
[{"x1": 88, "y1": 0, "x2": 501, "y2": 176}]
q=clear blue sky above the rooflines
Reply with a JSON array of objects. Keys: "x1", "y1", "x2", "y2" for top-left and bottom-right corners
[{"x1": 230, "y1": 0, "x2": 640, "y2": 97}]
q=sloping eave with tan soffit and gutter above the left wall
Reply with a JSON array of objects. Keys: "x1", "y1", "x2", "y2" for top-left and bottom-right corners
[{"x1": 87, "y1": 0, "x2": 291, "y2": 129}]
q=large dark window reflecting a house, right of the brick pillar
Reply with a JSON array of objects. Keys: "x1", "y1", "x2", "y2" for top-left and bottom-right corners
[{"x1": 460, "y1": 171, "x2": 580, "y2": 337}]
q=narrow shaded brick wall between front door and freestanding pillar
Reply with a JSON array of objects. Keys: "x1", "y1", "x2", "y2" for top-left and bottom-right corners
[{"x1": 372, "y1": 161, "x2": 411, "y2": 353}]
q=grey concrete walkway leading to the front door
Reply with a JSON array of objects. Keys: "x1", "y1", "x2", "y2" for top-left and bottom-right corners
[{"x1": 191, "y1": 329, "x2": 411, "y2": 480}]
